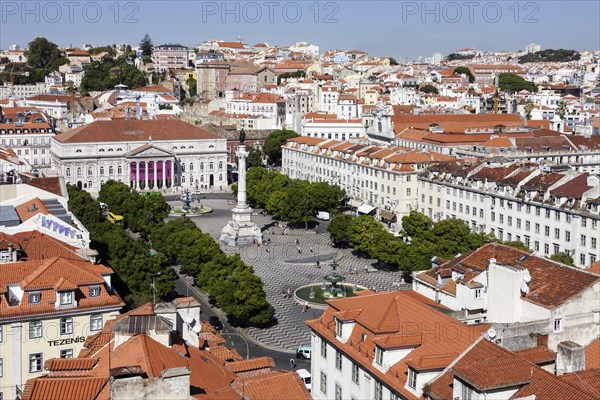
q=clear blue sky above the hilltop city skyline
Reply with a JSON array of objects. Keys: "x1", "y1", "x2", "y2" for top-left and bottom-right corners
[{"x1": 0, "y1": 0, "x2": 600, "y2": 59}]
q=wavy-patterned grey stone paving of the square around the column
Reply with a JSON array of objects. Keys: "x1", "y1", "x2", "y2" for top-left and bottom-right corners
[{"x1": 184, "y1": 199, "x2": 408, "y2": 351}]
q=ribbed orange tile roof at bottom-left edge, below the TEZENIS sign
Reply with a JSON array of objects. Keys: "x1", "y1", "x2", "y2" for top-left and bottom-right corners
[{"x1": 21, "y1": 377, "x2": 108, "y2": 400}]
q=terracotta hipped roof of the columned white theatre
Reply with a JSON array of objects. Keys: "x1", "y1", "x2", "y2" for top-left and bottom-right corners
[{"x1": 54, "y1": 119, "x2": 222, "y2": 143}]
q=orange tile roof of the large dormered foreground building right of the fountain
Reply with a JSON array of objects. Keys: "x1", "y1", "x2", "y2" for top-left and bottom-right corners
[{"x1": 307, "y1": 291, "x2": 489, "y2": 399}]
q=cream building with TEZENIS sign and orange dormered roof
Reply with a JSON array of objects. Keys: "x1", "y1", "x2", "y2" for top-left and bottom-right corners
[{"x1": 0, "y1": 257, "x2": 124, "y2": 399}]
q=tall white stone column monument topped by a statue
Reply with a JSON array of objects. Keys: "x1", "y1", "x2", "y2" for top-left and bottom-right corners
[{"x1": 220, "y1": 130, "x2": 262, "y2": 246}]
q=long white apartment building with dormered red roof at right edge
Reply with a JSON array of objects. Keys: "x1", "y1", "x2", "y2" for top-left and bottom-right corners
[{"x1": 418, "y1": 161, "x2": 600, "y2": 267}]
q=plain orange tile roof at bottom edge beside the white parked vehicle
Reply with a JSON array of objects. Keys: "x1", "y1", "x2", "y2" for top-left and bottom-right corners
[{"x1": 233, "y1": 371, "x2": 312, "y2": 400}]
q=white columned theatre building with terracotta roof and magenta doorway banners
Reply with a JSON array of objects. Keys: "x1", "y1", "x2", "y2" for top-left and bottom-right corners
[{"x1": 51, "y1": 120, "x2": 227, "y2": 195}]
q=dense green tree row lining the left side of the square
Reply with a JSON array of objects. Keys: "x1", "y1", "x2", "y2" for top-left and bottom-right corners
[{"x1": 69, "y1": 181, "x2": 273, "y2": 325}]
